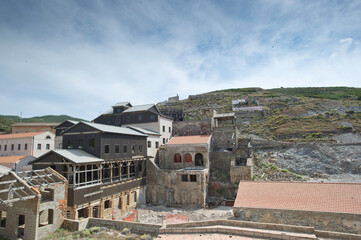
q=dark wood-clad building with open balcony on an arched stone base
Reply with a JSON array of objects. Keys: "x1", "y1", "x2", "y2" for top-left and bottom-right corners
[{"x1": 33, "y1": 122, "x2": 147, "y2": 219}]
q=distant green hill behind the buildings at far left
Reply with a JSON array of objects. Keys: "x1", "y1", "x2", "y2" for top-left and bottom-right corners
[{"x1": 0, "y1": 115, "x2": 84, "y2": 133}]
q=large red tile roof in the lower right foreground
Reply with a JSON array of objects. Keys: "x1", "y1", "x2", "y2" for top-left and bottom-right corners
[{"x1": 234, "y1": 182, "x2": 361, "y2": 214}]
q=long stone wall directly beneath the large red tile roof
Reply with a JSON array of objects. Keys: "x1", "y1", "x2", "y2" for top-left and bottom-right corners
[{"x1": 233, "y1": 207, "x2": 361, "y2": 234}]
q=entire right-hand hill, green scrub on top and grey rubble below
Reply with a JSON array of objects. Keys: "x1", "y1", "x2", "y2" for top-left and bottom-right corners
[{"x1": 158, "y1": 87, "x2": 361, "y2": 182}]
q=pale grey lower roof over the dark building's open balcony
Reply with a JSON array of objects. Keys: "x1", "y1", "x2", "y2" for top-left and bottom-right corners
[{"x1": 53, "y1": 149, "x2": 104, "y2": 163}]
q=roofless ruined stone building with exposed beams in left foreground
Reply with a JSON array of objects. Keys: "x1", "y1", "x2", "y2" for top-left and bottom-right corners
[{"x1": 0, "y1": 168, "x2": 67, "y2": 240}]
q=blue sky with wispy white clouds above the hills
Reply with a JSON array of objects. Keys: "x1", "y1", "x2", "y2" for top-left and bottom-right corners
[{"x1": 0, "y1": 0, "x2": 361, "y2": 120}]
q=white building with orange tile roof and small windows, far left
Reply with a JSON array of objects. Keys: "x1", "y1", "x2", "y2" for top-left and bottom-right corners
[{"x1": 0, "y1": 131, "x2": 55, "y2": 157}]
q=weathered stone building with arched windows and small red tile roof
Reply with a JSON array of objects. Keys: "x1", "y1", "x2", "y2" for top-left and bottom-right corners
[{"x1": 147, "y1": 135, "x2": 212, "y2": 207}]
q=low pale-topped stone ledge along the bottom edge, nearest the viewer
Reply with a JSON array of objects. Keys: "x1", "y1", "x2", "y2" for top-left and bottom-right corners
[{"x1": 159, "y1": 225, "x2": 317, "y2": 240}]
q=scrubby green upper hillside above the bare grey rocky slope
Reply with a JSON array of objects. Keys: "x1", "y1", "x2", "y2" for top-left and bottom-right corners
[{"x1": 158, "y1": 87, "x2": 361, "y2": 142}]
